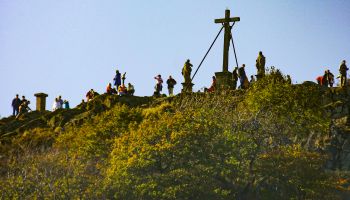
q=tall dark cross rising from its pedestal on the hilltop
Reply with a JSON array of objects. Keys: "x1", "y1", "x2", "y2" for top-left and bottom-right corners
[{"x1": 215, "y1": 9, "x2": 241, "y2": 72}]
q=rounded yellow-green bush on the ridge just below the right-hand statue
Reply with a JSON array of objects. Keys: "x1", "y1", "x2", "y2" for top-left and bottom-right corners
[{"x1": 243, "y1": 68, "x2": 330, "y2": 137}]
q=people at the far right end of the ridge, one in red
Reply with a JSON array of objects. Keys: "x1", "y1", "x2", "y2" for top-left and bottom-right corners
[{"x1": 316, "y1": 60, "x2": 349, "y2": 87}]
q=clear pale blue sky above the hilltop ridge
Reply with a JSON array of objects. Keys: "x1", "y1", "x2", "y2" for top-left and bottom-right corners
[{"x1": 0, "y1": 0, "x2": 350, "y2": 117}]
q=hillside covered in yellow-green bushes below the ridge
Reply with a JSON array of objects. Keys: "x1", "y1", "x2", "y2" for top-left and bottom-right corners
[{"x1": 0, "y1": 70, "x2": 349, "y2": 199}]
